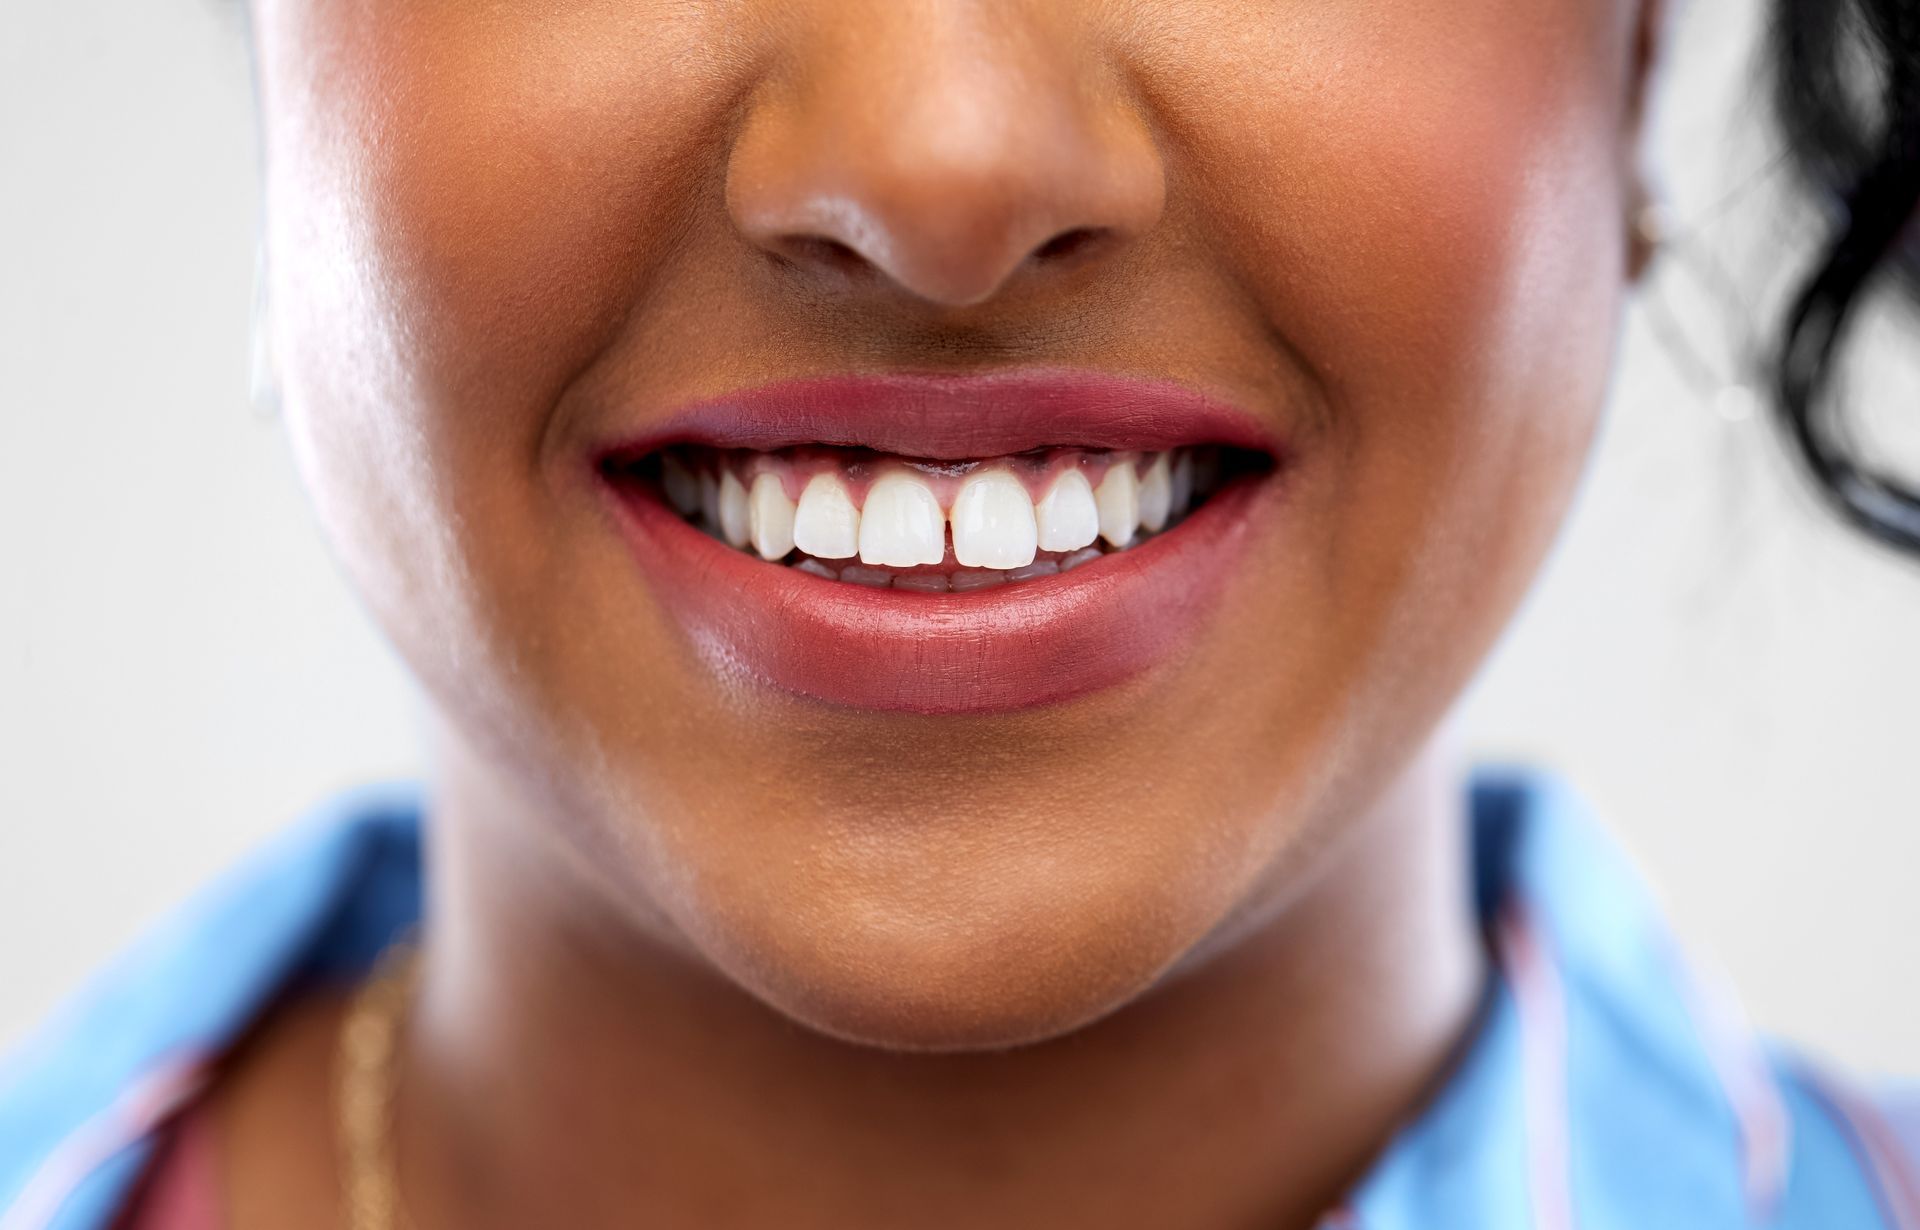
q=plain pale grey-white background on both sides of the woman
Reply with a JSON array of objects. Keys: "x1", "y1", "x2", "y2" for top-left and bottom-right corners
[{"x1": 0, "y1": 0, "x2": 1920, "y2": 1073}]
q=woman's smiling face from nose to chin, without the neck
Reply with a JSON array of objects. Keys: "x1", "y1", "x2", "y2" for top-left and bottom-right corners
[{"x1": 255, "y1": 0, "x2": 1644, "y2": 1048}]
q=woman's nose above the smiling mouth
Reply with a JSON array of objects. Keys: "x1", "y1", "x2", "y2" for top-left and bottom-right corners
[{"x1": 726, "y1": 0, "x2": 1165, "y2": 307}]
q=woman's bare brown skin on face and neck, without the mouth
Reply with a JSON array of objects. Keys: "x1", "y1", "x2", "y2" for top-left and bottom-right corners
[{"x1": 219, "y1": 0, "x2": 1655, "y2": 1230}]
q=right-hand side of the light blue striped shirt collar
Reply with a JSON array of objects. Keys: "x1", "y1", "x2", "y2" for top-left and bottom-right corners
[{"x1": 1332, "y1": 766, "x2": 1789, "y2": 1230}]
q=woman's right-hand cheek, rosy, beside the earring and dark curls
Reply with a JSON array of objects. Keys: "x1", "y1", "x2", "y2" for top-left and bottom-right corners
[{"x1": 1185, "y1": 0, "x2": 1628, "y2": 686}]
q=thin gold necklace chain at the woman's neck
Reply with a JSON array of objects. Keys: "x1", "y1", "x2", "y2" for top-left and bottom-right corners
[{"x1": 334, "y1": 938, "x2": 420, "y2": 1230}]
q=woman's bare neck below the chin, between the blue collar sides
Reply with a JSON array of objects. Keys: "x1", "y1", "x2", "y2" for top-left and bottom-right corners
[{"x1": 397, "y1": 729, "x2": 1486, "y2": 1230}]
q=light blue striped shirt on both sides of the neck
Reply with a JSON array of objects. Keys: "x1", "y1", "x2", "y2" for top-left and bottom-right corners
[{"x1": 0, "y1": 766, "x2": 1920, "y2": 1230}]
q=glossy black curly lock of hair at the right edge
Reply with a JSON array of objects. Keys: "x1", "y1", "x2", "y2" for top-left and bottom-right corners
[{"x1": 1770, "y1": 0, "x2": 1920, "y2": 558}]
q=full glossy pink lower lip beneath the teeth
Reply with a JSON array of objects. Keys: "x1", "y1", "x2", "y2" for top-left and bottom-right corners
[{"x1": 601, "y1": 476, "x2": 1275, "y2": 714}]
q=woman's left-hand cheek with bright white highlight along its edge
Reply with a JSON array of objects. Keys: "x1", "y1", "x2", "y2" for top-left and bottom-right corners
[{"x1": 255, "y1": 0, "x2": 739, "y2": 706}]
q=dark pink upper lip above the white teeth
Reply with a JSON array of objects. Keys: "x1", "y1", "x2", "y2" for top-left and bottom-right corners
[{"x1": 601, "y1": 367, "x2": 1283, "y2": 461}]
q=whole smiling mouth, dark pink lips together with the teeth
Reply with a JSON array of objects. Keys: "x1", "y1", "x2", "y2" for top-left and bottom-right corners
[{"x1": 591, "y1": 368, "x2": 1286, "y2": 714}]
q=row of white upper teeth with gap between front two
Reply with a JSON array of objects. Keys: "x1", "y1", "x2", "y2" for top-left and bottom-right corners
[{"x1": 660, "y1": 449, "x2": 1196, "y2": 587}]
